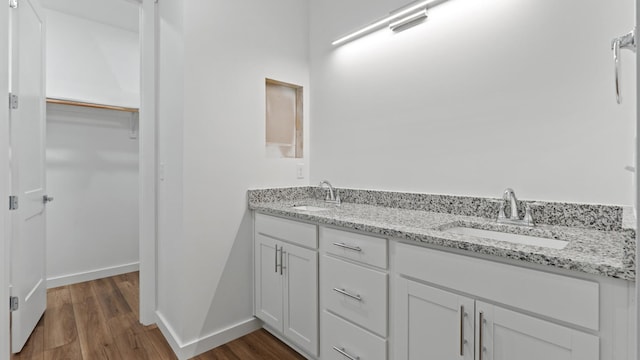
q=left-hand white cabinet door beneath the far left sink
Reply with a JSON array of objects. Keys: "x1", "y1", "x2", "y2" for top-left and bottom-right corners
[{"x1": 254, "y1": 234, "x2": 284, "y2": 331}]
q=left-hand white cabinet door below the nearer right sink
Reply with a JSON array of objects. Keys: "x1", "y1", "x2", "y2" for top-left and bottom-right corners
[{"x1": 395, "y1": 278, "x2": 475, "y2": 360}]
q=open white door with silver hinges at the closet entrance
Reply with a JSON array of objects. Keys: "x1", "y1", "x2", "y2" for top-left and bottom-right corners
[{"x1": 10, "y1": 0, "x2": 47, "y2": 353}]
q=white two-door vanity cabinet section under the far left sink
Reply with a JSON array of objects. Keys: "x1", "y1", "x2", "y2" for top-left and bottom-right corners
[{"x1": 254, "y1": 214, "x2": 318, "y2": 357}]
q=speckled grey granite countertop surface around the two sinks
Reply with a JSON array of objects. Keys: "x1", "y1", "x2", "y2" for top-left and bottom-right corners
[{"x1": 249, "y1": 188, "x2": 635, "y2": 280}]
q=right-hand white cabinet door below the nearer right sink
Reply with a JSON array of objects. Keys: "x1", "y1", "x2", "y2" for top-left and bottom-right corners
[{"x1": 476, "y1": 301, "x2": 600, "y2": 360}]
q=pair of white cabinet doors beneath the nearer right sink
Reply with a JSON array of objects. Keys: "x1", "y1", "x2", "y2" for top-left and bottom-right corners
[{"x1": 395, "y1": 278, "x2": 599, "y2": 360}]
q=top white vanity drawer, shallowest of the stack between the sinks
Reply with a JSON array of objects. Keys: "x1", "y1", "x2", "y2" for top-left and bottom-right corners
[{"x1": 320, "y1": 227, "x2": 387, "y2": 269}]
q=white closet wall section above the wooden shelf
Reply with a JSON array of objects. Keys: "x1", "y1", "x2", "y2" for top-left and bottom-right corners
[{"x1": 47, "y1": 7, "x2": 140, "y2": 108}]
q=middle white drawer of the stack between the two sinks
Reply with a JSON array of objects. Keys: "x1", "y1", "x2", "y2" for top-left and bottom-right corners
[{"x1": 320, "y1": 255, "x2": 388, "y2": 337}]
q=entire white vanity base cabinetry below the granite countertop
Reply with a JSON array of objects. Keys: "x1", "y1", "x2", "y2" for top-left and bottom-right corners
[{"x1": 254, "y1": 213, "x2": 636, "y2": 360}]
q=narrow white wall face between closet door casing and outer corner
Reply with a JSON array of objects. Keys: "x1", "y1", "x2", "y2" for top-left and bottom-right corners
[{"x1": 157, "y1": 0, "x2": 186, "y2": 339}]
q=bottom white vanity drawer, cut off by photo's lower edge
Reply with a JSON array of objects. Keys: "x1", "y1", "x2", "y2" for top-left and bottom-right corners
[{"x1": 320, "y1": 311, "x2": 387, "y2": 360}]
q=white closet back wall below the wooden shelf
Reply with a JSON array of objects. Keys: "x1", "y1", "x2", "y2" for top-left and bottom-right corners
[{"x1": 46, "y1": 105, "x2": 138, "y2": 287}]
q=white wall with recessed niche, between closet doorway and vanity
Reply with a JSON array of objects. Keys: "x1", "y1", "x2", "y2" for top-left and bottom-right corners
[{"x1": 158, "y1": 0, "x2": 310, "y2": 356}]
